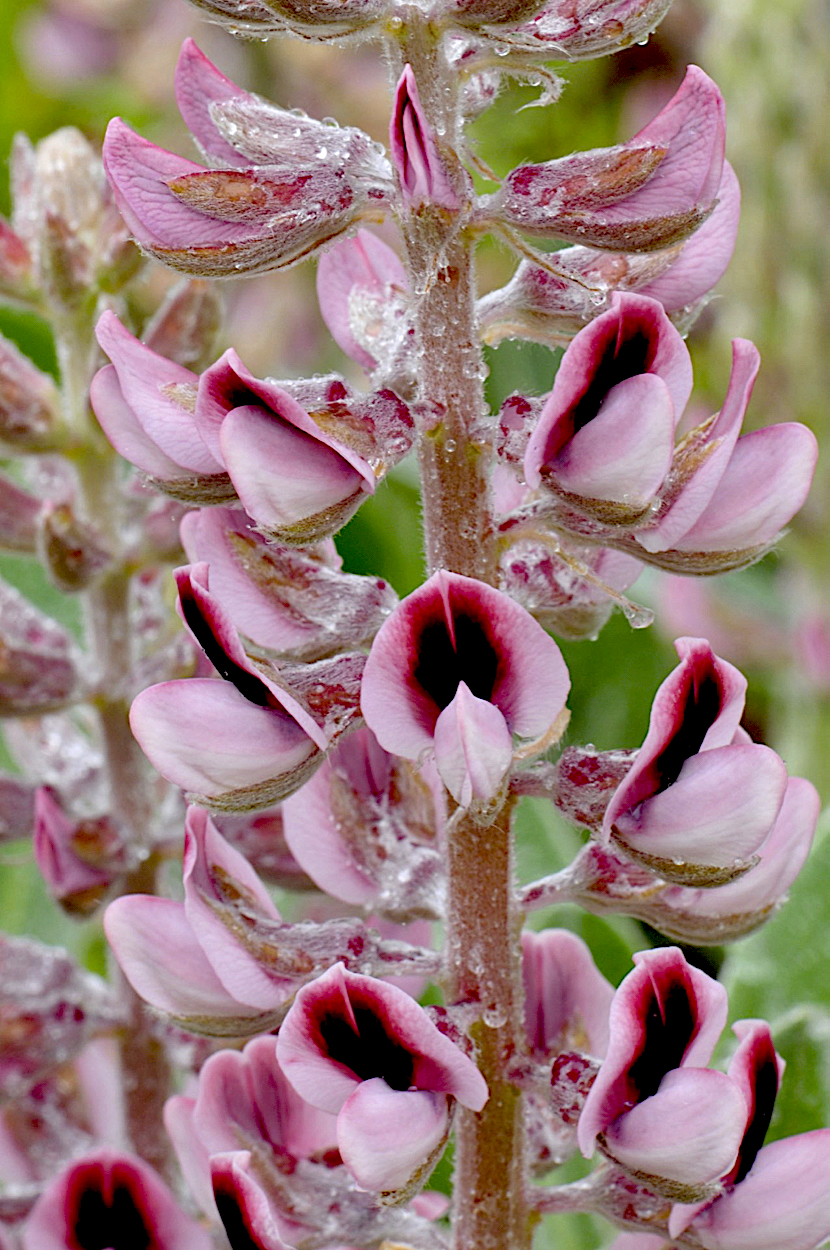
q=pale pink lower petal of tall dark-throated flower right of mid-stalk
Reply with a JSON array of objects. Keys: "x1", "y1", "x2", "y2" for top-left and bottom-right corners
[{"x1": 614, "y1": 744, "x2": 786, "y2": 868}]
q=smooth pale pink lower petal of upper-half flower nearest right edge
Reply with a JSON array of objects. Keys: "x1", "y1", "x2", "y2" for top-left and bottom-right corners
[{"x1": 674, "y1": 421, "x2": 819, "y2": 551}]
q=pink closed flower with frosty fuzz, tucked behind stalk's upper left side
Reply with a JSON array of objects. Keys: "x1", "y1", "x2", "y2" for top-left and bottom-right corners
[{"x1": 318, "y1": 230, "x2": 411, "y2": 374}]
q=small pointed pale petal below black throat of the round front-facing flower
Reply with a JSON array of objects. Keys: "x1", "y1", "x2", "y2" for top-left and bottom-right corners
[{"x1": 435, "y1": 681, "x2": 513, "y2": 808}]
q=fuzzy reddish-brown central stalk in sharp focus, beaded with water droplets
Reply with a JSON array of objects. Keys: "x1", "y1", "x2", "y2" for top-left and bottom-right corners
[{"x1": 391, "y1": 21, "x2": 531, "y2": 1250}]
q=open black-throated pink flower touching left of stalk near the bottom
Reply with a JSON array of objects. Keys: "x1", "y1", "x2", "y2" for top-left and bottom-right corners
[{"x1": 276, "y1": 964, "x2": 488, "y2": 1191}]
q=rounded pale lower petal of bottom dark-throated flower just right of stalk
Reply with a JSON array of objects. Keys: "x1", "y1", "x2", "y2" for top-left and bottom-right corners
[{"x1": 605, "y1": 1068, "x2": 746, "y2": 1185}]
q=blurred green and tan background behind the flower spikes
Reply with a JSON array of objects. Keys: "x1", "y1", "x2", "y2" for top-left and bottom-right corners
[{"x1": 0, "y1": 0, "x2": 830, "y2": 1248}]
